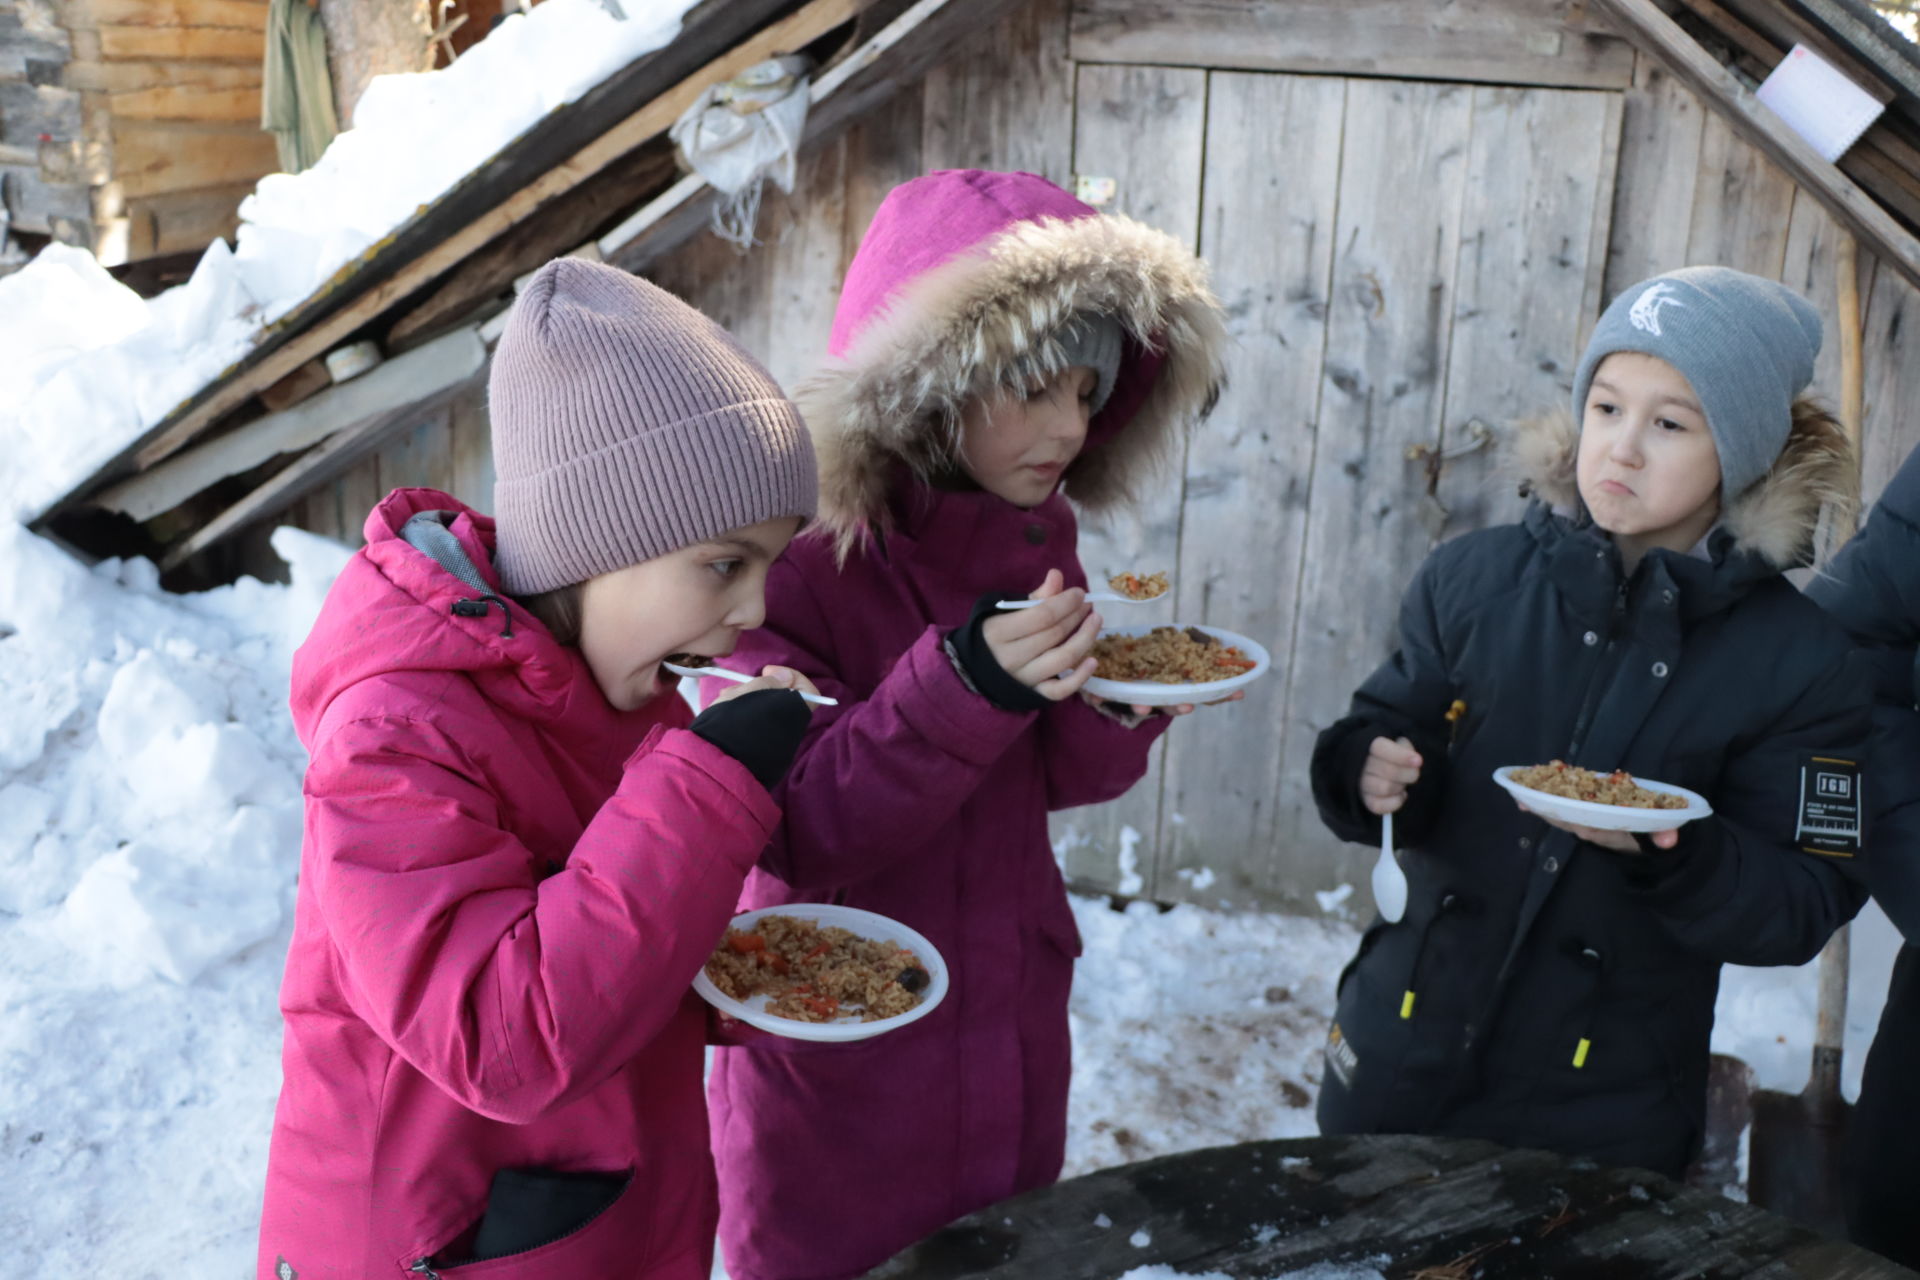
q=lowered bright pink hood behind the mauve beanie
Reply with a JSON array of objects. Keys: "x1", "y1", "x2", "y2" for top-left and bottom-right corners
[{"x1": 292, "y1": 489, "x2": 599, "y2": 750}]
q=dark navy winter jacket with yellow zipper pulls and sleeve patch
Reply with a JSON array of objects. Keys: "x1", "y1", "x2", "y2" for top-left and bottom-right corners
[{"x1": 1313, "y1": 412, "x2": 1870, "y2": 1174}]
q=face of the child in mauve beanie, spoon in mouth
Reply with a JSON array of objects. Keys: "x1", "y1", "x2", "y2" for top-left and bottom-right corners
[{"x1": 580, "y1": 516, "x2": 801, "y2": 712}]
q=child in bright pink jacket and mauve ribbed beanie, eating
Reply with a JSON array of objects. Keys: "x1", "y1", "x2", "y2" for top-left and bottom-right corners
[{"x1": 259, "y1": 259, "x2": 816, "y2": 1280}]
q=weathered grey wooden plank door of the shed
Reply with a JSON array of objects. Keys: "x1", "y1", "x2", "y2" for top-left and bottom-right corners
[{"x1": 1056, "y1": 67, "x2": 1622, "y2": 910}]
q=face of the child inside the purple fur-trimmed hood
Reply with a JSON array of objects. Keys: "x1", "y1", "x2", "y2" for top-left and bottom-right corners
[{"x1": 960, "y1": 365, "x2": 1096, "y2": 507}]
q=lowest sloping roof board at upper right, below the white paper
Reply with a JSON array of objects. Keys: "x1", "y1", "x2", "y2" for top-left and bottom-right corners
[{"x1": 1592, "y1": 0, "x2": 1920, "y2": 286}]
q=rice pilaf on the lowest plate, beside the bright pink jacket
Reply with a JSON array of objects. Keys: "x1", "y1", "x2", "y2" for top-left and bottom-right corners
[{"x1": 707, "y1": 915, "x2": 929, "y2": 1023}]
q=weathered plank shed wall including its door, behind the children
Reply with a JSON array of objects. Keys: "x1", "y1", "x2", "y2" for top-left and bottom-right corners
[{"x1": 274, "y1": 0, "x2": 1920, "y2": 912}]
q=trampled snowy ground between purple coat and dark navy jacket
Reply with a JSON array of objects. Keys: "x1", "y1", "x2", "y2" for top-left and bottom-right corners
[{"x1": 1064, "y1": 898, "x2": 1359, "y2": 1176}]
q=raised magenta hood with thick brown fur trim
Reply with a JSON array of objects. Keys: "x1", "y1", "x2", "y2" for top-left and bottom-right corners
[{"x1": 795, "y1": 171, "x2": 1227, "y2": 555}]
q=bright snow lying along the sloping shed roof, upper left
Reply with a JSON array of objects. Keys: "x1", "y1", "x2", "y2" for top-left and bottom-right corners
[{"x1": 0, "y1": 0, "x2": 693, "y2": 518}]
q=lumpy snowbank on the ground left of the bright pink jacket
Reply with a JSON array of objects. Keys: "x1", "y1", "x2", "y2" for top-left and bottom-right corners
[{"x1": 0, "y1": 524, "x2": 348, "y2": 1276}]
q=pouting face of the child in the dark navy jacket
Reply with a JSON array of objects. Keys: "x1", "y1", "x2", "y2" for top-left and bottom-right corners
[{"x1": 1578, "y1": 351, "x2": 1720, "y2": 551}]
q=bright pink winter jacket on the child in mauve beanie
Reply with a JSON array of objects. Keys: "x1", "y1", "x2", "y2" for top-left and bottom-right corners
[{"x1": 259, "y1": 489, "x2": 778, "y2": 1280}]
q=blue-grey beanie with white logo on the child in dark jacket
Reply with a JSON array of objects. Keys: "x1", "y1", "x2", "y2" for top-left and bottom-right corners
[{"x1": 1572, "y1": 267, "x2": 1820, "y2": 501}]
